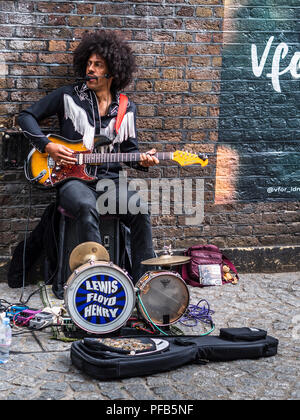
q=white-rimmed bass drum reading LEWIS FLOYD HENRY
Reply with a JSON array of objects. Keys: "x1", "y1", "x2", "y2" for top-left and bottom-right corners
[{"x1": 64, "y1": 261, "x2": 135, "y2": 334}]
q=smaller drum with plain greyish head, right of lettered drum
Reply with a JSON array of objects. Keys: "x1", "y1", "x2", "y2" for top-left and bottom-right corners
[{"x1": 136, "y1": 271, "x2": 190, "y2": 326}]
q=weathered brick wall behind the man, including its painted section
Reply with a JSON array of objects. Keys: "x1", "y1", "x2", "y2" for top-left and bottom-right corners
[{"x1": 0, "y1": 0, "x2": 300, "y2": 282}]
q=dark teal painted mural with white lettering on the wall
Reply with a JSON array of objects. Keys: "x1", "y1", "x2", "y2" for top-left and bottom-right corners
[{"x1": 215, "y1": 0, "x2": 300, "y2": 203}]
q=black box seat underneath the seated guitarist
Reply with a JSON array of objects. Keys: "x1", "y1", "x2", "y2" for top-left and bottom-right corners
[{"x1": 55, "y1": 206, "x2": 131, "y2": 298}]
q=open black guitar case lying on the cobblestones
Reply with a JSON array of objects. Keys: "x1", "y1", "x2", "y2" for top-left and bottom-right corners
[{"x1": 71, "y1": 327, "x2": 278, "y2": 380}]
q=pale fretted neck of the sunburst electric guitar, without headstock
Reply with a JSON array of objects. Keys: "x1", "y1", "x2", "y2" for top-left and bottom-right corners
[{"x1": 75, "y1": 152, "x2": 173, "y2": 165}]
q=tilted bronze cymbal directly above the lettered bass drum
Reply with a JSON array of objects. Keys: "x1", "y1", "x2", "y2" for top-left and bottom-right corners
[{"x1": 69, "y1": 242, "x2": 110, "y2": 272}]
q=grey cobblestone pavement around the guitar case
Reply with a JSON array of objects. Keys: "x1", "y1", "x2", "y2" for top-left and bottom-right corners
[{"x1": 0, "y1": 273, "x2": 300, "y2": 401}]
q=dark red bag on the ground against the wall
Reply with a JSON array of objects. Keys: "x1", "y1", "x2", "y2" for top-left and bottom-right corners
[{"x1": 181, "y1": 245, "x2": 238, "y2": 287}]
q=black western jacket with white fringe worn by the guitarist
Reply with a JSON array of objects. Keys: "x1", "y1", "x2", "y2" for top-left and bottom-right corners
[{"x1": 18, "y1": 83, "x2": 147, "y2": 178}]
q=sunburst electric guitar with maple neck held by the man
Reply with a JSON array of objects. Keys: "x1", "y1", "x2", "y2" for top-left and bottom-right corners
[{"x1": 24, "y1": 135, "x2": 208, "y2": 189}]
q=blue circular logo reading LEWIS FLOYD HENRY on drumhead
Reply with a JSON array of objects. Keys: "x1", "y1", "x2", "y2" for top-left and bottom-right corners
[{"x1": 75, "y1": 274, "x2": 126, "y2": 325}]
